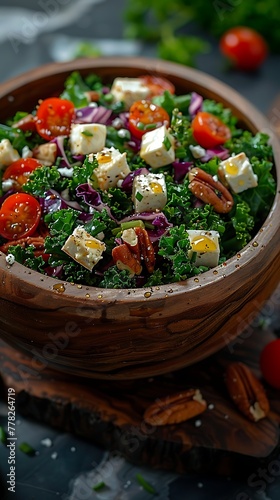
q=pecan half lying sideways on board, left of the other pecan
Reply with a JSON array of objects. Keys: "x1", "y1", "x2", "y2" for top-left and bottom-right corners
[{"x1": 144, "y1": 389, "x2": 207, "y2": 426}]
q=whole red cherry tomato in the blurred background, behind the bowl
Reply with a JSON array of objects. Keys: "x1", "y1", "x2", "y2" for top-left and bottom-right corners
[{"x1": 220, "y1": 26, "x2": 268, "y2": 71}]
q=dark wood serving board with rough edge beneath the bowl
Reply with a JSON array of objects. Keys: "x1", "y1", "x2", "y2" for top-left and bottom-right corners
[{"x1": 0, "y1": 330, "x2": 280, "y2": 476}]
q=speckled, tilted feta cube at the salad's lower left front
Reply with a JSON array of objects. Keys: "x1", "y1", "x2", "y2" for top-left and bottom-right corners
[{"x1": 61, "y1": 226, "x2": 106, "y2": 271}]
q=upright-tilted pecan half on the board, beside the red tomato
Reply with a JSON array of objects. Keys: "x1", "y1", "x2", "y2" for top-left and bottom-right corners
[{"x1": 225, "y1": 362, "x2": 270, "y2": 422}]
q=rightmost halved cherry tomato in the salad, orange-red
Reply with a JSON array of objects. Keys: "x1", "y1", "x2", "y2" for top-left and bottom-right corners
[{"x1": 191, "y1": 111, "x2": 231, "y2": 148}]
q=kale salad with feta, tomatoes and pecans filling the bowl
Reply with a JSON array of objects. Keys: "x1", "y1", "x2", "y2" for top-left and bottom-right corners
[{"x1": 0, "y1": 72, "x2": 276, "y2": 288}]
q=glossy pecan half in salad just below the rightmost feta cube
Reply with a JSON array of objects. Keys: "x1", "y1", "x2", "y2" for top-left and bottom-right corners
[{"x1": 189, "y1": 168, "x2": 233, "y2": 214}]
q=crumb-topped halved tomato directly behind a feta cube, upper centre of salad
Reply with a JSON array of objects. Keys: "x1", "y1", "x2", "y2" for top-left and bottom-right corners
[{"x1": 128, "y1": 100, "x2": 170, "y2": 139}]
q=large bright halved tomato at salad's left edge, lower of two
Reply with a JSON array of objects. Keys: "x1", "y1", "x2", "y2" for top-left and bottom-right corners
[{"x1": 0, "y1": 193, "x2": 41, "y2": 240}]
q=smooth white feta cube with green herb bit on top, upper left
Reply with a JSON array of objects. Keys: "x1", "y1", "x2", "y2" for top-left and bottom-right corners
[{"x1": 70, "y1": 123, "x2": 106, "y2": 155}]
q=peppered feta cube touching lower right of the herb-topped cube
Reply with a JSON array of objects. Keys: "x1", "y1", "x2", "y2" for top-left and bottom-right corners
[{"x1": 92, "y1": 147, "x2": 130, "y2": 191}]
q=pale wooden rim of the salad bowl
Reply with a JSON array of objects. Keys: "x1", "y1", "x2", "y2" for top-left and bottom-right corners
[{"x1": 0, "y1": 56, "x2": 280, "y2": 303}]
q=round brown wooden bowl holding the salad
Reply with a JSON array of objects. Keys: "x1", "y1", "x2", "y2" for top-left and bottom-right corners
[{"x1": 0, "y1": 58, "x2": 280, "y2": 379}]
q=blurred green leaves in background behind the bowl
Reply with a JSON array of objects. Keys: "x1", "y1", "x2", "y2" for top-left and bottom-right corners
[{"x1": 124, "y1": 0, "x2": 280, "y2": 66}]
